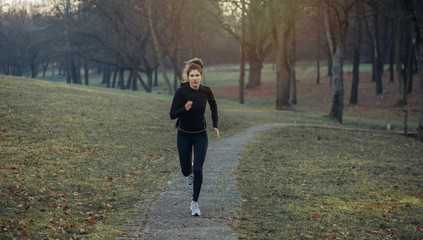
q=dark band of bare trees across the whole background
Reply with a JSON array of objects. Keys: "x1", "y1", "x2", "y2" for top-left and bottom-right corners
[{"x1": 0, "y1": 0, "x2": 423, "y2": 135}]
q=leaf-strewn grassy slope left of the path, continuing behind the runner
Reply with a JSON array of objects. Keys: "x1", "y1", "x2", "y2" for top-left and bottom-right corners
[{"x1": 0, "y1": 75, "x2": 296, "y2": 239}]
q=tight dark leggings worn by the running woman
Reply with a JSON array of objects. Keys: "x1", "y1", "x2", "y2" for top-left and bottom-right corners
[{"x1": 178, "y1": 130, "x2": 208, "y2": 202}]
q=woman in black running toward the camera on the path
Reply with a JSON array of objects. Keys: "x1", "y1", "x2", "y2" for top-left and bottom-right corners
[{"x1": 170, "y1": 58, "x2": 220, "y2": 216}]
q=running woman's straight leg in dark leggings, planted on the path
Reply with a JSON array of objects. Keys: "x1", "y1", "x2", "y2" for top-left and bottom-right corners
[{"x1": 192, "y1": 132, "x2": 208, "y2": 202}]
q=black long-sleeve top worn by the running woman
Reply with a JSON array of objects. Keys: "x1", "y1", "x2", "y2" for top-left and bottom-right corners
[{"x1": 170, "y1": 82, "x2": 218, "y2": 133}]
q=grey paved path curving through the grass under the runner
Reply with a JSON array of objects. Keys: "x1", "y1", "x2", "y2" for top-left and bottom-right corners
[{"x1": 124, "y1": 124, "x2": 288, "y2": 240}]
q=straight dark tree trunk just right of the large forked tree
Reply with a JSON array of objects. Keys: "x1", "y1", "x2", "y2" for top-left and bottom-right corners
[{"x1": 350, "y1": 4, "x2": 363, "y2": 104}]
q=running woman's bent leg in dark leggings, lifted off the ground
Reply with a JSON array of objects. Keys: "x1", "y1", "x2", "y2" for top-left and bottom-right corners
[{"x1": 177, "y1": 131, "x2": 192, "y2": 177}]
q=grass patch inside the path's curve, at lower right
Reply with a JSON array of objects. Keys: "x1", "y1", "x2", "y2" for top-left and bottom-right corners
[{"x1": 235, "y1": 126, "x2": 423, "y2": 239}]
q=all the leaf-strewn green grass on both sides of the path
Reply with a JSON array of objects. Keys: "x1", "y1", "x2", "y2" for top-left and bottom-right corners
[{"x1": 4, "y1": 61, "x2": 423, "y2": 239}]
